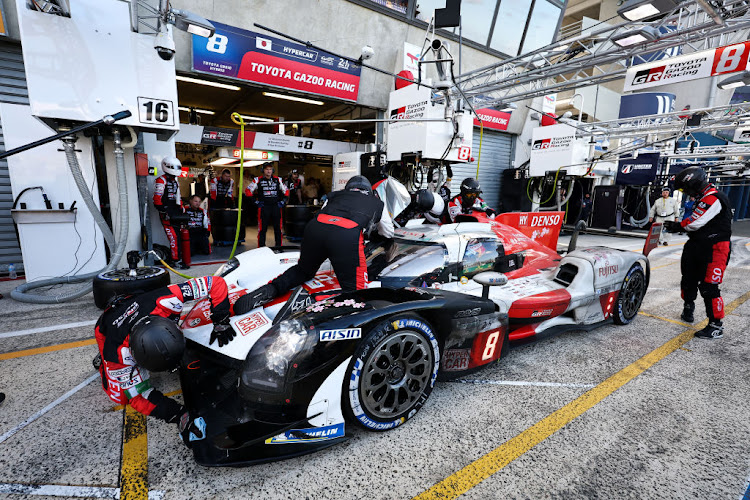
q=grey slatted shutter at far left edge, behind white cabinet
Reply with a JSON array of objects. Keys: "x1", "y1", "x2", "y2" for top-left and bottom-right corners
[{"x1": 0, "y1": 42, "x2": 29, "y2": 275}]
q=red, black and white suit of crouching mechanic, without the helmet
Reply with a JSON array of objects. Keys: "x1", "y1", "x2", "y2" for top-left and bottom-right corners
[{"x1": 94, "y1": 276, "x2": 230, "y2": 422}]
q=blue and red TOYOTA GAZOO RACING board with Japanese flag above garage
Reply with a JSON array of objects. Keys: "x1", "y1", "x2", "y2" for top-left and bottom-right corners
[{"x1": 193, "y1": 21, "x2": 362, "y2": 101}]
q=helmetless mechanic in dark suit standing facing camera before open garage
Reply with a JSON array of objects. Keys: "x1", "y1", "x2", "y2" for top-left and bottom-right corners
[{"x1": 245, "y1": 163, "x2": 289, "y2": 248}]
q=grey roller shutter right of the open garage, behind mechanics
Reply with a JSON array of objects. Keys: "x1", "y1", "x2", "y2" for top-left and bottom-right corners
[{"x1": 450, "y1": 127, "x2": 513, "y2": 208}]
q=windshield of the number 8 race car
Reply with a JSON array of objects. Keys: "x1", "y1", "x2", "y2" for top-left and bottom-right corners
[{"x1": 367, "y1": 239, "x2": 448, "y2": 288}]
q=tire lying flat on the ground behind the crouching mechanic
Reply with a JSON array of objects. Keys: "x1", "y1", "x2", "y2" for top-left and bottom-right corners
[{"x1": 94, "y1": 267, "x2": 169, "y2": 309}]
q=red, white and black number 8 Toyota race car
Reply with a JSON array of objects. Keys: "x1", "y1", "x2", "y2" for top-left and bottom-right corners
[{"x1": 180, "y1": 212, "x2": 659, "y2": 465}]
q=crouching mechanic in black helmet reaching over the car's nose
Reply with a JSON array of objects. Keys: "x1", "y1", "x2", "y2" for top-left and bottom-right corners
[{"x1": 94, "y1": 276, "x2": 235, "y2": 445}]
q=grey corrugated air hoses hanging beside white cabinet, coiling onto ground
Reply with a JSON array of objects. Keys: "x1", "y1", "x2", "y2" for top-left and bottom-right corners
[{"x1": 10, "y1": 129, "x2": 129, "y2": 304}]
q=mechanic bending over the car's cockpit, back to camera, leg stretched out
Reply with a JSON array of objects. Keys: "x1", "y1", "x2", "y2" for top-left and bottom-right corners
[{"x1": 235, "y1": 175, "x2": 393, "y2": 314}]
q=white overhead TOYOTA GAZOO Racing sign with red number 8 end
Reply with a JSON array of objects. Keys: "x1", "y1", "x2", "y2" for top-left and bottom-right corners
[{"x1": 624, "y1": 42, "x2": 750, "y2": 92}]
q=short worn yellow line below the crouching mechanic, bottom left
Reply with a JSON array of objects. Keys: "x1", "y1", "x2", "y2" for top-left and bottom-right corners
[{"x1": 120, "y1": 406, "x2": 148, "y2": 500}]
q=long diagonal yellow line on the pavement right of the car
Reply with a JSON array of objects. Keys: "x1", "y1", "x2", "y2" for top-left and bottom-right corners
[{"x1": 414, "y1": 292, "x2": 750, "y2": 500}]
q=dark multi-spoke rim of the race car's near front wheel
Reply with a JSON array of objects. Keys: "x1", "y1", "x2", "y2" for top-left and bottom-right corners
[{"x1": 361, "y1": 331, "x2": 434, "y2": 418}]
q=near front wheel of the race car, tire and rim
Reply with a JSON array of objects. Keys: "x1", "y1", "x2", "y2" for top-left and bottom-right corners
[{"x1": 342, "y1": 315, "x2": 440, "y2": 431}]
